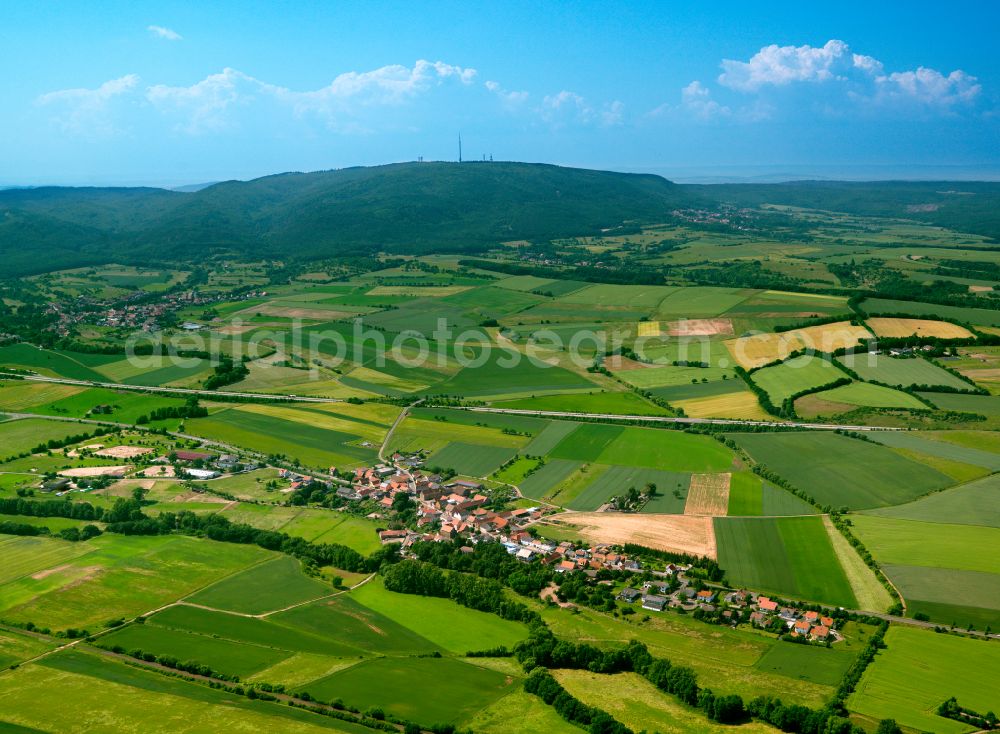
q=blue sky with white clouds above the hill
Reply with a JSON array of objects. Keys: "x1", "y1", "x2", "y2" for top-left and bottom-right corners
[{"x1": 0, "y1": 0, "x2": 1000, "y2": 185}]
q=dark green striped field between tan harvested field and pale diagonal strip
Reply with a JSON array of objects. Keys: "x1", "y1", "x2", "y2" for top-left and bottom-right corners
[{"x1": 715, "y1": 517, "x2": 857, "y2": 608}]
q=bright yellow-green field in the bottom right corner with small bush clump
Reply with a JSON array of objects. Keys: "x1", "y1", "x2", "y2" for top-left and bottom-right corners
[{"x1": 847, "y1": 626, "x2": 1000, "y2": 734}]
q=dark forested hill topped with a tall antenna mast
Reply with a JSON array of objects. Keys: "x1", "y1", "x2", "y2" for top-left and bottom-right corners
[{"x1": 0, "y1": 162, "x2": 699, "y2": 276}]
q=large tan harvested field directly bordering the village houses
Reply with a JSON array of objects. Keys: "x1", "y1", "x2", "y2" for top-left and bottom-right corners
[{"x1": 546, "y1": 512, "x2": 716, "y2": 558}]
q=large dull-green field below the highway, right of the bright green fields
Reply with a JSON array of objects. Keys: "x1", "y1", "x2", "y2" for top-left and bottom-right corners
[{"x1": 728, "y1": 431, "x2": 952, "y2": 509}]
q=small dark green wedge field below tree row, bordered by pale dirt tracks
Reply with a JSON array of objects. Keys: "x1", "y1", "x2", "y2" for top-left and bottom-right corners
[{"x1": 189, "y1": 556, "x2": 334, "y2": 614}]
